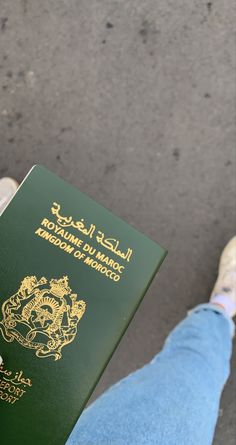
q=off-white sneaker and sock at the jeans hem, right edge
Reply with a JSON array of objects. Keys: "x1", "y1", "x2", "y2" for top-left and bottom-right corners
[{"x1": 210, "y1": 236, "x2": 236, "y2": 317}]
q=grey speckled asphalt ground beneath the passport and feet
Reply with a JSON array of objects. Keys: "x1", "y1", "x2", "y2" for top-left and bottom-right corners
[{"x1": 0, "y1": 0, "x2": 236, "y2": 445}]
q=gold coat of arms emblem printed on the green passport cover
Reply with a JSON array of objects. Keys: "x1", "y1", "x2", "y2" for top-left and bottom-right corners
[{"x1": 0, "y1": 276, "x2": 86, "y2": 360}]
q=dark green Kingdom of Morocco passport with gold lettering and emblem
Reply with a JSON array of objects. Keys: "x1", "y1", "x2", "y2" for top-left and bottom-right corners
[{"x1": 0, "y1": 166, "x2": 166, "y2": 445}]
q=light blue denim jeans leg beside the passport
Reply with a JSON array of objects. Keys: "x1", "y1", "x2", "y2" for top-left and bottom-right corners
[{"x1": 66, "y1": 304, "x2": 234, "y2": 445}]
